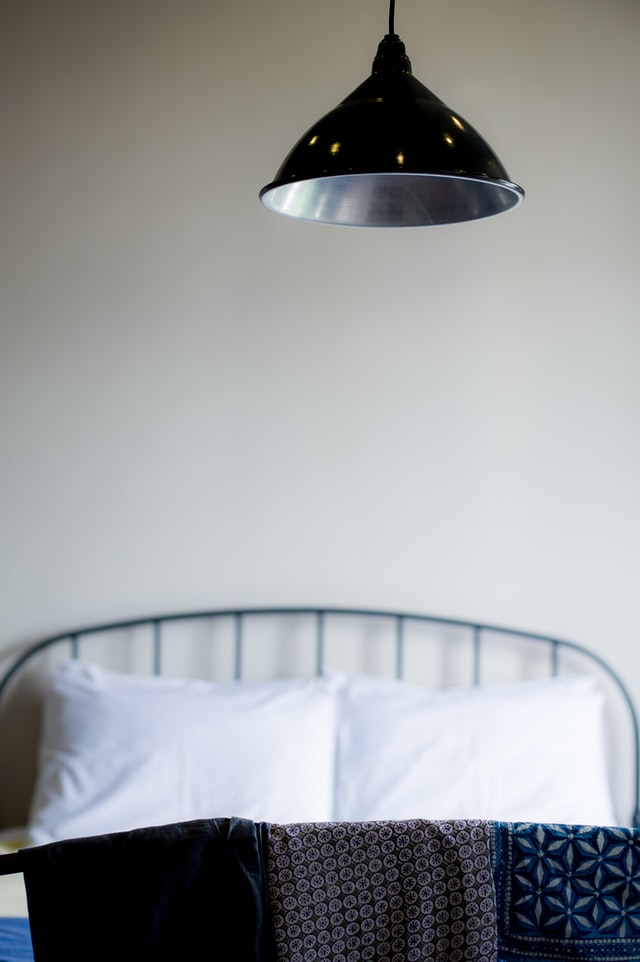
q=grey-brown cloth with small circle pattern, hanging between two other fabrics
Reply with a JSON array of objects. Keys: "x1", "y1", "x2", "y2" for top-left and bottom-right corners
[{"x1": 267, "y1": 820, "x2": 497, "y2": 962}]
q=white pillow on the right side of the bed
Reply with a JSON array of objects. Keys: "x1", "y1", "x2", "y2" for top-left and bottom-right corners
[{"x1": 336, "y1": 676, "x2": 616, "y2": 825}]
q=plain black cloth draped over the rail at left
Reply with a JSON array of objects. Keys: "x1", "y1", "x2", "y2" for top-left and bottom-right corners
[{"x1": 21, "y1": 818, "x2": 273, "y2": 962}]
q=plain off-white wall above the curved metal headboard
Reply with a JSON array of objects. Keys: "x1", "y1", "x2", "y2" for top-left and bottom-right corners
[{"x1": 0, "y1": 0, "x2": 640, "y2": 728}]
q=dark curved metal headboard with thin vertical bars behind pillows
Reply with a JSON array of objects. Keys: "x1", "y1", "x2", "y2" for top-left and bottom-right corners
[{"x1": 0, "y1": 606, "x2": 640, "y2": 826}]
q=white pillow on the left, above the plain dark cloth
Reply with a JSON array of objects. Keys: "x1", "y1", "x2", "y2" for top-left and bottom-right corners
[{"x1": 29, "y1": 660, "x2": 337, "y2": 844}]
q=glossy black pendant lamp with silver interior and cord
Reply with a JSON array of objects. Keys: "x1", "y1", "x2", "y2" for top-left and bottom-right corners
[{"x1": 260, "y1": 0, "x2": 524, "y2": 227}]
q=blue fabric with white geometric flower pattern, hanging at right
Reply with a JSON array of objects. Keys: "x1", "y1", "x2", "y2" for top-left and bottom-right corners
[{"x1": 493, "y1": 822, "x2": 640, "y2": 962}]
